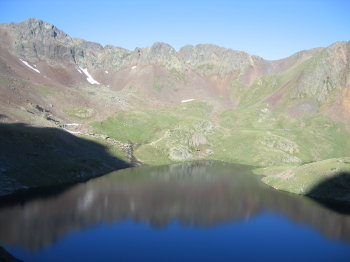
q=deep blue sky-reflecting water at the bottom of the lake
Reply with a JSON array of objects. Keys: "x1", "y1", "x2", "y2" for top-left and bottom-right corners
[{"x1": 8, "y1": 213, "x2": 350, "y2": 262}]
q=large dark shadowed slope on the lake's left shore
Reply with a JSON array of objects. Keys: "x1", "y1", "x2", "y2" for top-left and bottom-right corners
[{"x1": 0, "y1": 121, "x2": 131, "y2": 205}]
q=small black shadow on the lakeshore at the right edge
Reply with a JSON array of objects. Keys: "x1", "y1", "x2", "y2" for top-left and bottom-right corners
[{"x1": 306, "y1": 172, "x2": 350, "y2": 214}]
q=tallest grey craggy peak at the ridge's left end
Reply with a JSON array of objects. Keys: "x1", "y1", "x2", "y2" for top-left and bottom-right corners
[{"x1": 1, "y1": 18, "x2": 103, "y2": 65}]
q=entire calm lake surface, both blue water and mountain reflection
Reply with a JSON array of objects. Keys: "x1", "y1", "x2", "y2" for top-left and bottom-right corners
[{"x1": 0, "y1": 162, "x2": 350, "y2": 262}]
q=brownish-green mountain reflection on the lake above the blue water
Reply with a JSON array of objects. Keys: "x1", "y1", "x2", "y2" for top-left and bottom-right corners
[{"x1": 0, "y1": 161, "x2": 350, "y2": 255}]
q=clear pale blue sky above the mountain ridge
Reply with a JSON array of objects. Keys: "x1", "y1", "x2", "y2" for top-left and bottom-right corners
[{"x1": 0, "y1": 0, "x2": 350, "y2": 59}]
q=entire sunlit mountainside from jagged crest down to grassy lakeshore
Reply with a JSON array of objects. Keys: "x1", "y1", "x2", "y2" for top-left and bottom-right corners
[{"x1": 0, "y1": 19, "x2": 350, "y2": 196}]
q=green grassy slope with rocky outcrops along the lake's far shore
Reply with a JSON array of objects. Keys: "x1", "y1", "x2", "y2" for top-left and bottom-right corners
[{"x1": 93, "y1": 99, "x2": 350, "y2": 166}]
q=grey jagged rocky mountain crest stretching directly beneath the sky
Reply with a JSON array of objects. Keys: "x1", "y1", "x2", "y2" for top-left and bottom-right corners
[{"x1": 0, "y1": 18, "x2": 349, "y2": 94}]
